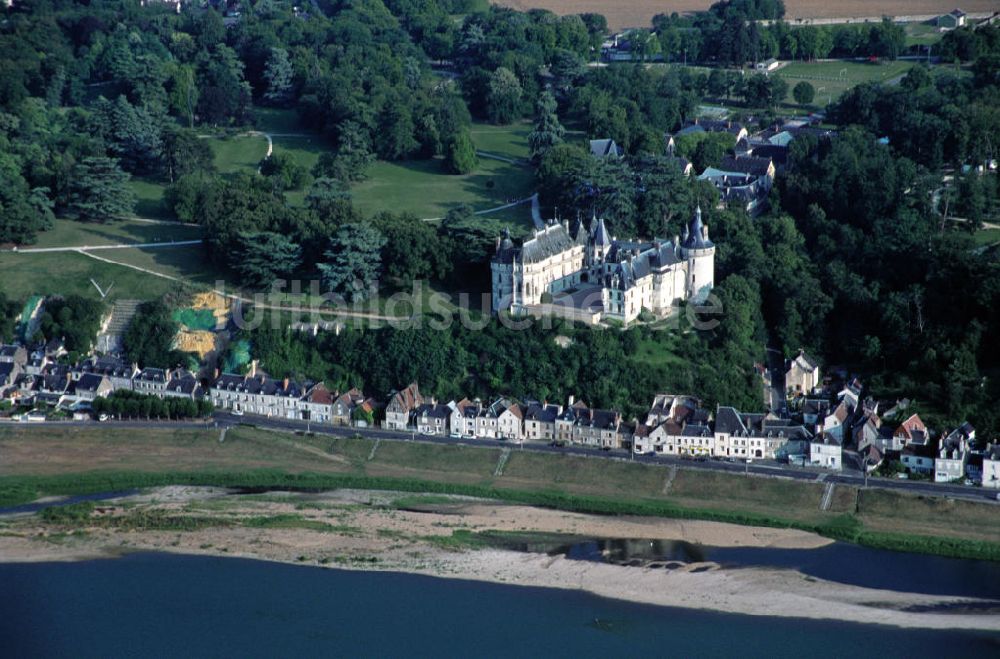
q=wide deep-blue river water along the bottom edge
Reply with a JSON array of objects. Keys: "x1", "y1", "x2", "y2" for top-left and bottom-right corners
[{"x1": 0, "y1": 553, "x2": 1000, "y2": 659}]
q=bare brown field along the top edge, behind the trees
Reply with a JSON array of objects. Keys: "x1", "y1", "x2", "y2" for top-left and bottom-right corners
[{"x1": 493, "y1": 0, "x2": 997, "y2": 30}]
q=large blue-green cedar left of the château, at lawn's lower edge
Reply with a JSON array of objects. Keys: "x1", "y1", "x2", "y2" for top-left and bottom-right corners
[{"x1": 318, "y1": 224, "x2": 385, "y2": 302}]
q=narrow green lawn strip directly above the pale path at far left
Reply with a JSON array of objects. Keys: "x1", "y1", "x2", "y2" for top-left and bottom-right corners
[{"x1": 30, "y1": 220, "x2": 201, "y2": 256}]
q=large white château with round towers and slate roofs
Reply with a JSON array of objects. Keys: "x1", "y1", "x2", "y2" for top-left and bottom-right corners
[{"x1": 491, "y1": 208, "x2": 715, "y2": 323}]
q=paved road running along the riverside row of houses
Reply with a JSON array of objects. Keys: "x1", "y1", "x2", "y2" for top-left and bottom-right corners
[{"x1": 10, "y1": 412, "x2": 997, "y2": 503}]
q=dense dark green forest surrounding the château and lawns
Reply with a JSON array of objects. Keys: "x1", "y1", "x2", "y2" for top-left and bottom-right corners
[{"x1": 0, "y1": 0, "x2": 1000, "y2": 435}]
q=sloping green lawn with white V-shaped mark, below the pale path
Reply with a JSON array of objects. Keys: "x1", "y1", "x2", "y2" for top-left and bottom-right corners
[{"x1": 0, "y1": 249, "x2": 188, "y2": 300}]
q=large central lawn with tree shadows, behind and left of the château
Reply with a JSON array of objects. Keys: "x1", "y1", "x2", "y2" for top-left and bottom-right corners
[{"x1": 352, "y1": 158, "x2": 534, "y2": 218}]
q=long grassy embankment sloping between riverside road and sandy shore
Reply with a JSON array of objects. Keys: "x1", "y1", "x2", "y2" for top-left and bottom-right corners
[{"x1": 0, "y1": 427, "x2": 1000, "y2": 560}]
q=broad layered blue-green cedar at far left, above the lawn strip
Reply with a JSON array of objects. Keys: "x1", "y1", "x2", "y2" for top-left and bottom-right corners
[{"x1": 64, "y1": 157, "x2": 135, "y2": 224}]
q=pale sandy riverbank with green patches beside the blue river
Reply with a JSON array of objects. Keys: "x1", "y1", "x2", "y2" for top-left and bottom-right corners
[{"x1": 0, "y1": 488, "x2": 1000, "y2": 631}]
